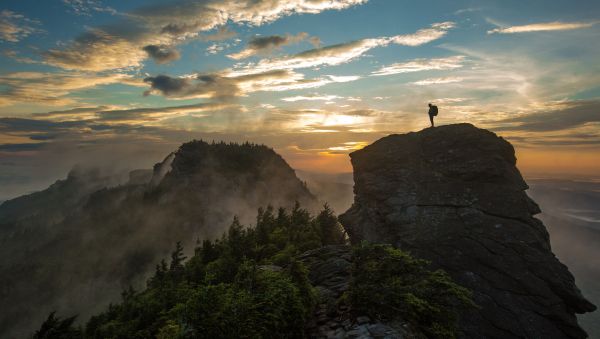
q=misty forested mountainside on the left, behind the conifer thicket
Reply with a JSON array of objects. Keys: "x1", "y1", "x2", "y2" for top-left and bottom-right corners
[{"x1": 0, "y1": 141, "x2": 315, "y2": 338}]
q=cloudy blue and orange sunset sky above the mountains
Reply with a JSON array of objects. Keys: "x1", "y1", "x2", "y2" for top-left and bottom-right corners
[{"x1": 0, "y1": 0, "x2": 600, "y2": 200}]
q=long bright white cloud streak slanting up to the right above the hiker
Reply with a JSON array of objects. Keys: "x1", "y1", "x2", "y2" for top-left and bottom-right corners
[{"x1": 231, "y1": 22, "x2": 454, "y2": 75}]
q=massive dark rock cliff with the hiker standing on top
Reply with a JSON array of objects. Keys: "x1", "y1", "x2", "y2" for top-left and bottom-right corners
[{"x1": 340, "y1": 124, "x2": 595, "y2": 338}]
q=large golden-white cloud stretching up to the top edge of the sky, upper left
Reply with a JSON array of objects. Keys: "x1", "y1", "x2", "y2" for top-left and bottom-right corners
[{"x1": 43, "y1": 0, "x2": 366, "y2": 71}]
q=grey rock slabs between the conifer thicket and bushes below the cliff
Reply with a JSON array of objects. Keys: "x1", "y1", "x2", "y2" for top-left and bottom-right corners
[{"x1": 298, "y1": 245, "x2": 422, "y2": 339}]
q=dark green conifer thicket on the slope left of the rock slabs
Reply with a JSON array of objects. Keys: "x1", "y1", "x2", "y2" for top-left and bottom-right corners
[{"x1": 40, "y1": 204, "x2": 344, "y2": 338}]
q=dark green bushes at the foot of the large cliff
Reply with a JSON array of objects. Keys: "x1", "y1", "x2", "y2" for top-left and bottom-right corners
[{"x1": 348, "y1": 243, "x2": 475, "y2": 338}]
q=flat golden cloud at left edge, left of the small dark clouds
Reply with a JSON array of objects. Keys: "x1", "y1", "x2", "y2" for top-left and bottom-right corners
[{"x1": 0, "y1": 72, "x2": 144, "y2": 106}]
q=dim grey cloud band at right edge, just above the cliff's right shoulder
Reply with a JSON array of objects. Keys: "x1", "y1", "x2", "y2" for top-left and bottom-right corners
[{"x1": 494, "y1": 100, "x2": 600, "y2": 132}]
